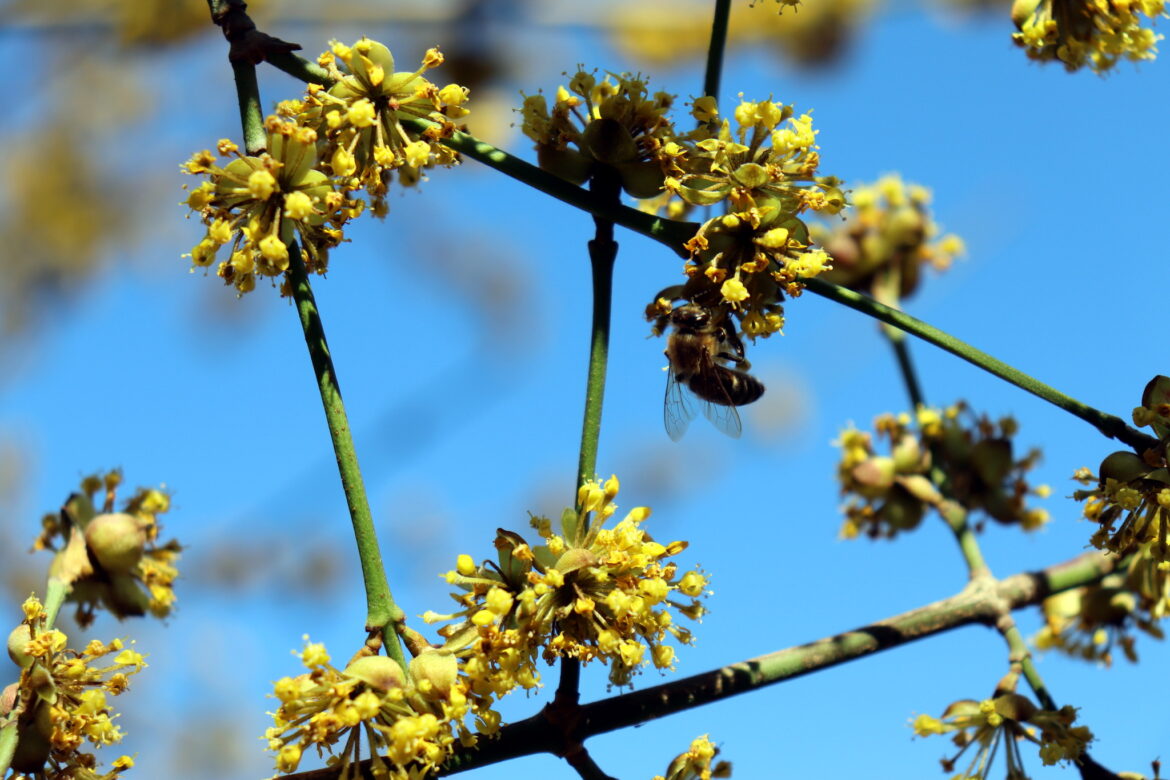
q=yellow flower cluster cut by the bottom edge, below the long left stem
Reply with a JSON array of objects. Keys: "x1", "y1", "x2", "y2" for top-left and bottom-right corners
[{"x1": 264, "y1": 641, "x2": 489, "y2": 780}]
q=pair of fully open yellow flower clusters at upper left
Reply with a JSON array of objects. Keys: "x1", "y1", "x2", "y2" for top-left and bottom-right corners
[{"x1": 183, "y1": 39, "x2": 468, "y2": 295}]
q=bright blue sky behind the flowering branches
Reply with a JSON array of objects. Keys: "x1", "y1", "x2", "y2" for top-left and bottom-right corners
[{"x1": 0, "y1": 0, "x2": 1170, "y2": 780}]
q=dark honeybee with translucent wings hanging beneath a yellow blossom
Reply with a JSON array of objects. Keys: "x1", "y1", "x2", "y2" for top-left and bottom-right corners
[{"x1": 663, "y1": 303, "x2": 764, "y2": 441}]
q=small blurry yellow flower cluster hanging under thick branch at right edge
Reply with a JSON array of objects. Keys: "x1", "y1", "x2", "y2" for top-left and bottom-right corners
[{"x1": 1032, "y1": 573, "x2": 1163, "y2": 667}]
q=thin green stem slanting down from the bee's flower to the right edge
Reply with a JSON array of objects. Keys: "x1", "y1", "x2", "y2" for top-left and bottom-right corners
[{"x1": 804, "y1": 278, "x2": 1157, "y2": 451}]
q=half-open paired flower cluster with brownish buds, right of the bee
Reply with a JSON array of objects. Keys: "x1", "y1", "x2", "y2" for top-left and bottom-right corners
[{"x1": 837, "y1": 401, "x2": 1049, "y2": 539}]
